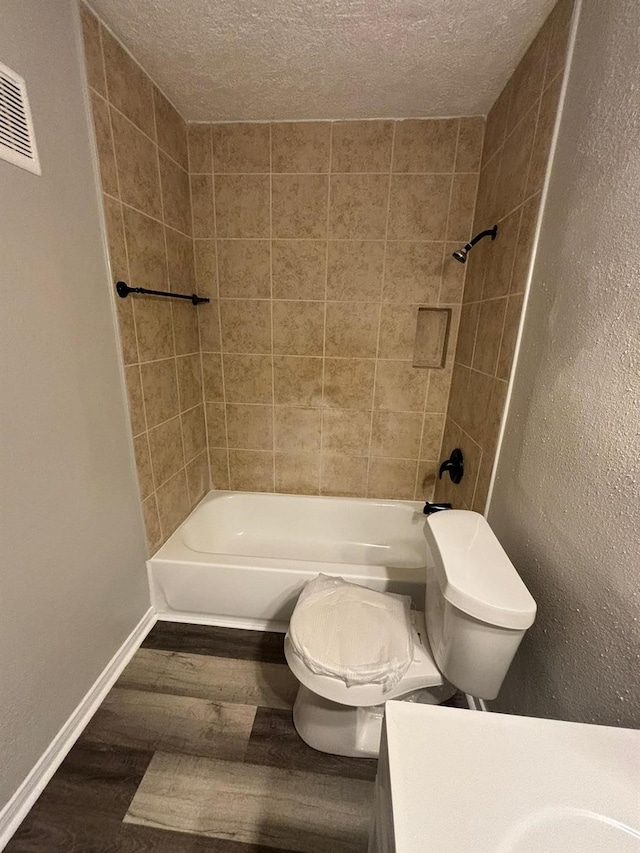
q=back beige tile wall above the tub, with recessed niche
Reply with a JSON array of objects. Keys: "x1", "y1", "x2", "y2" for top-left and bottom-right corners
[{"x1": 189, "y1": 119, "x2": 484, "y2": 498}]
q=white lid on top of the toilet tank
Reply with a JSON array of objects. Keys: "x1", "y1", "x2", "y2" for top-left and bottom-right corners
[{"x1": 425, "y1": 509, "x2": 536, "y2": 630}]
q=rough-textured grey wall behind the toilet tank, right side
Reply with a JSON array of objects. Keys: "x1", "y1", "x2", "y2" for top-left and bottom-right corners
[{"x1": 488, "y1": 0, "x2": 640, "y2": 727}]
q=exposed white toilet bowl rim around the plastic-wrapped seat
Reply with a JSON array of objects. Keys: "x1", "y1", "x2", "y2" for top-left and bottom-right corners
[{"x1": 284, "y1": 611, "x2": 445, "y2": 708}]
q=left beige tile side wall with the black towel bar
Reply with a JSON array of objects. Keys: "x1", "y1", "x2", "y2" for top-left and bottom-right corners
[{"x1": 81, "y1": 7, "x2": 209, "y2": 550}]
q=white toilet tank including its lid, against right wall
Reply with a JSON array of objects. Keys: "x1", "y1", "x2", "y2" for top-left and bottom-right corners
[{"x1": 425, "y1": 509, "x2": 536, "y2": 699}]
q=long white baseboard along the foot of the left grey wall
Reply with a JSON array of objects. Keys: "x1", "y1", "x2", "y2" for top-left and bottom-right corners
[{"x1": 0, "y1": 607, "x2": 156, "y2": 850}]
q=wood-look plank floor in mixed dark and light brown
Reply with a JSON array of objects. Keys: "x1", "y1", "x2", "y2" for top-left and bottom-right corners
[{"x1": 6, "y1": 622, "x2": 458, "y2": 853}]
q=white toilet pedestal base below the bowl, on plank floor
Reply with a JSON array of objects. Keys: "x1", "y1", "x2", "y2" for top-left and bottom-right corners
[{"x1": 293, "y1": 684, "x2": 456, "y2": 758}]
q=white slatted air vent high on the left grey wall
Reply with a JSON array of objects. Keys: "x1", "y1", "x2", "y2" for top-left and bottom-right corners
[{"x1": 0, "y1": 62, "x2": 41, "y2": 175}]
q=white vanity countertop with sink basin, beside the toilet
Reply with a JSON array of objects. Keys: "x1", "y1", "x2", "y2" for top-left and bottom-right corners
[{"x1": 370, "y1": 702, "x2": 640, "y2": 853}]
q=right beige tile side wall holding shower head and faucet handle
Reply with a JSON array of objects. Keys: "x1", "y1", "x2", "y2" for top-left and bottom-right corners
[{"x1": 436, "y1": 0, "x2": 573, "y2": 512}]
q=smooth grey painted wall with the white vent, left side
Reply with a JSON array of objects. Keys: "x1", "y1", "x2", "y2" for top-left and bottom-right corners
[{"x1": 0, "y1": 0, "x2": 149, "y2": 812}]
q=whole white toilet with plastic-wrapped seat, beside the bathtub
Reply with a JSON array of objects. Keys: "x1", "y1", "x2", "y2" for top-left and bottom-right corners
[{"x1": 284, "y1": 510, "x2": 536, "y2": 757}]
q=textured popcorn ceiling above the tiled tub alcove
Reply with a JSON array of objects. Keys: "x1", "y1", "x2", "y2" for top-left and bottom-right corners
[{"x1": 91, "y1": 0, "x2": 554, "y2": 121}]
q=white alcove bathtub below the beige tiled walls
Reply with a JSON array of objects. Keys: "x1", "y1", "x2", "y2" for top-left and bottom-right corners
[{"x1": 147, "y1": 492, "x2": 428, "y2": 631}]
